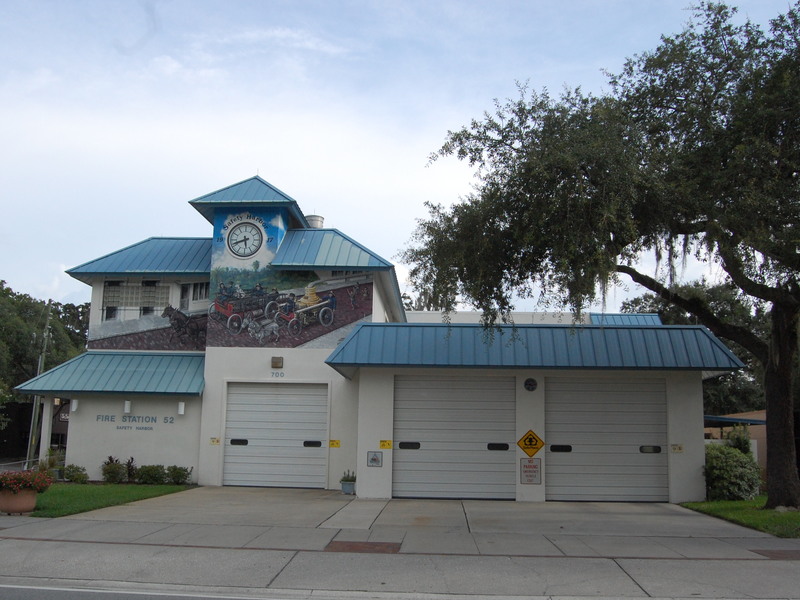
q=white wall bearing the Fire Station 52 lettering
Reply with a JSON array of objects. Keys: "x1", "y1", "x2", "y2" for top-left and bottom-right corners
[{"x1": 66, "y1": 394, "x2": 201, "y2": 481}]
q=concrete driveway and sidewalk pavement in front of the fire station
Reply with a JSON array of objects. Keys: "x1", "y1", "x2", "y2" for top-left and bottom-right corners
[{"x1": 0, "y1": 487, "x2": 800, "y2": 598}]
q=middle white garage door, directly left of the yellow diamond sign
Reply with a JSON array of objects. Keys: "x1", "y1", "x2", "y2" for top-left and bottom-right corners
[{"x1": 392, "y1": 377, "x2": 516, "y2": 499}]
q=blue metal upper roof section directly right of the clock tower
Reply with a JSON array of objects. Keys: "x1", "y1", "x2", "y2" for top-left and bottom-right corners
[{"x1": 272, "y1": 229, "x2": 393, "y2": 270}]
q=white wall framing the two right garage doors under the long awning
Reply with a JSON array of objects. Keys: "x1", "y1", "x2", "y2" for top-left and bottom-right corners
[{"x1": 356, "y1": 369, "x2": 705, "y2": 502}]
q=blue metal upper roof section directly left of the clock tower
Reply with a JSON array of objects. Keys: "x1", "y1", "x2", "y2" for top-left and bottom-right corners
[{"x1": 67, "y1": 238, "x2": 211, "y2": 283}]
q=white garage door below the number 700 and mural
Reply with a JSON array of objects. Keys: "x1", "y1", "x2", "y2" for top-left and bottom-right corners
[{"x1": 222, "y1": 383, "x2": 328, "y2": 488}]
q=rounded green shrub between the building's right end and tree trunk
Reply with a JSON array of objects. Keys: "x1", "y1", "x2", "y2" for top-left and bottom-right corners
[{"x1": 703, "y1": 444, "x2": 760, "y2": 500}]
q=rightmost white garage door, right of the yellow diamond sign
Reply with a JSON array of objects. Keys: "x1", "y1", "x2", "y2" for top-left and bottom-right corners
[{"x1": 544, "y1": 378, "x2": 669, "y2": 502}]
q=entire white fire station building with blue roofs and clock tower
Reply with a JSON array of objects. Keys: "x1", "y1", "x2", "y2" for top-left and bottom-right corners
[{"x1": 17, "y1": 177, "x2": 742, "y2": 502}]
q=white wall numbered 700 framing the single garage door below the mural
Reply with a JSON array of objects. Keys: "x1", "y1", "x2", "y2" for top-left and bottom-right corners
[{"x1": 198, "y1": 347, "x2": 358, "y2": 489}]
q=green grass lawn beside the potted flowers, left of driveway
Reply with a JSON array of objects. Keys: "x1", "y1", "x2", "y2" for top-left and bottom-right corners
[{"x1": 31, "y1": 483, "x2": 191, "y2": 517}]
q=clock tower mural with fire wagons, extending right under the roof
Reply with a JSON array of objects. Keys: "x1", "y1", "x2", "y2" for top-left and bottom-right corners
[{"x1": 206, "y1": 209, "x2": 372, "y2": 348}]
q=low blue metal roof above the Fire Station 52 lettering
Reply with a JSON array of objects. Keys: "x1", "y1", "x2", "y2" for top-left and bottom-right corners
[{"x1": 14, "y1": 352, "x2": 205, "y2": 396}]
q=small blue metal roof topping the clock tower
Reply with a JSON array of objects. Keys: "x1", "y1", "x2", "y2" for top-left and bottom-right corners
[{"x1": 189, "y1": 175, "x2": 308, "y2": 227}]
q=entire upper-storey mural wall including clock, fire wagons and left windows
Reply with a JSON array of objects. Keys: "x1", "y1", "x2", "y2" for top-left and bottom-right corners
[{"x1": 88, "y1": 208, "x2": 373, "y2": 351}]
